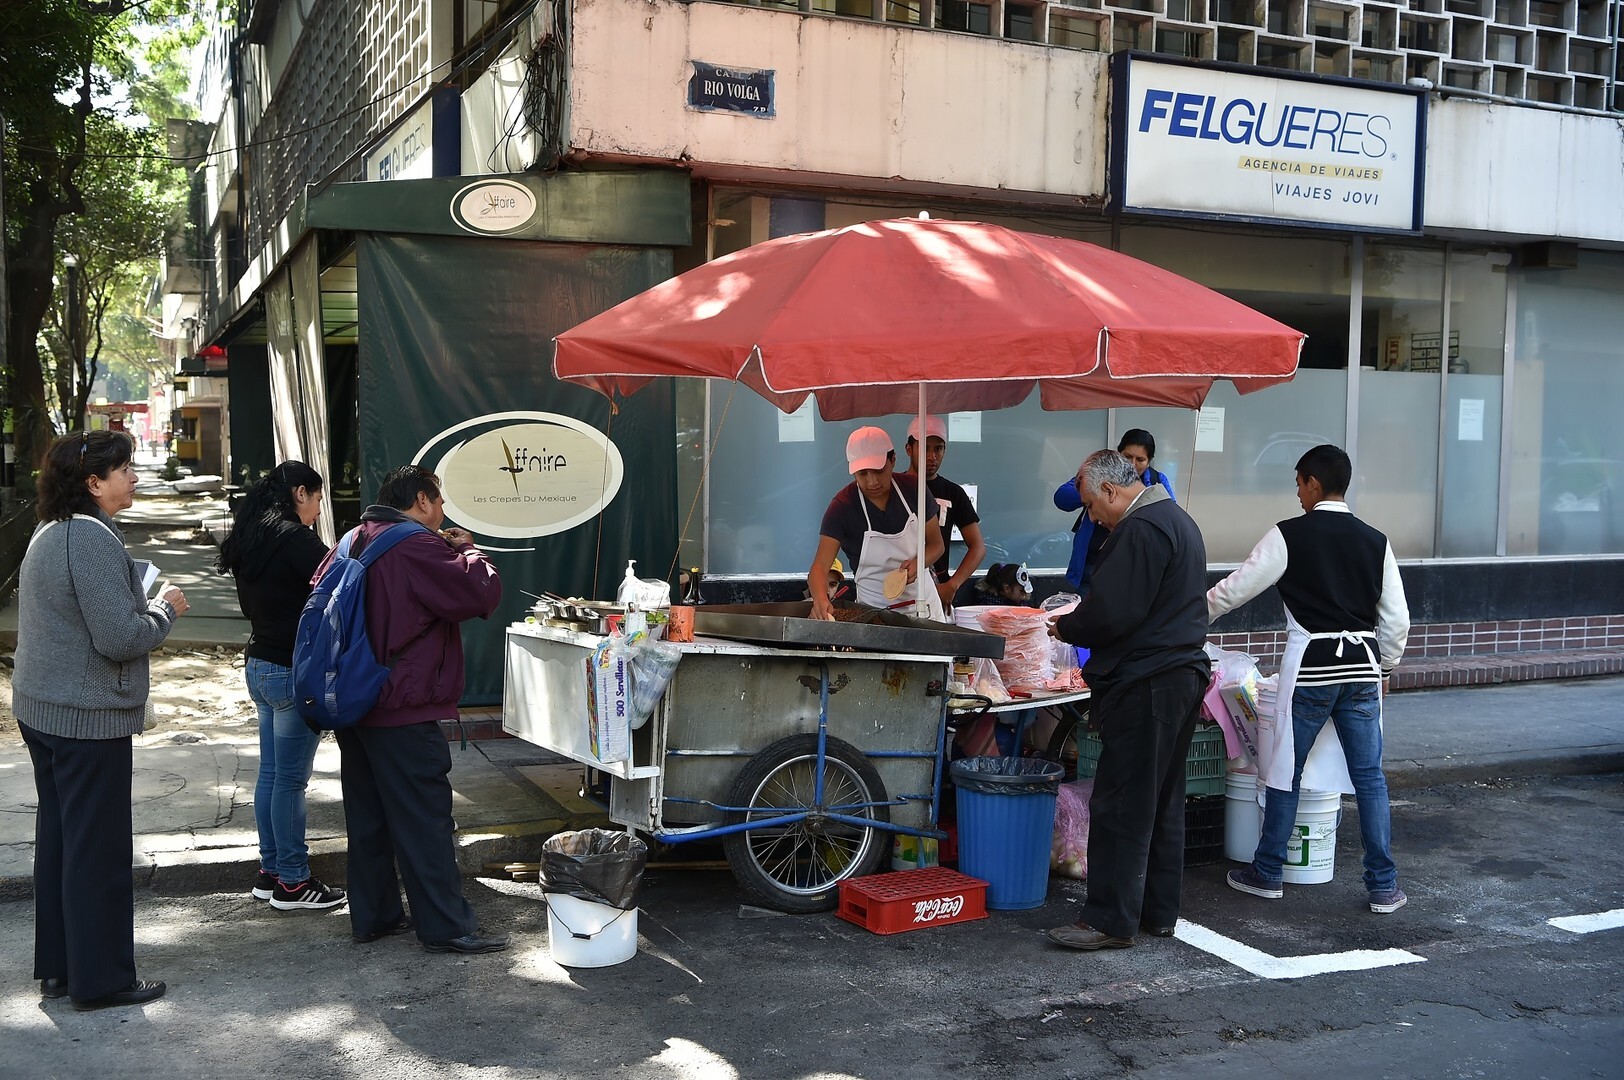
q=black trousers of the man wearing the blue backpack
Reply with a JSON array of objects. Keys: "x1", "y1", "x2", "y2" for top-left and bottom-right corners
[{"x1": 338, "y1": 723, "x2": 476, "y2": 942}]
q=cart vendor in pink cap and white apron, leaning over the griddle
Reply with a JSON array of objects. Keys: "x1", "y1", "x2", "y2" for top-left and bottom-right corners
[{"x1": 807, "y1": 427, "x2": 947, "y2": 619}]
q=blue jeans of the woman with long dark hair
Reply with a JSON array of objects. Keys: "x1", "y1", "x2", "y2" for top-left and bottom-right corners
[{"x1": 247, "y1": 656, "x2": 322, "y2": 885}]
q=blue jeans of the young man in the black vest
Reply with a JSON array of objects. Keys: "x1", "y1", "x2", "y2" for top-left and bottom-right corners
[{"x1": 1252, "y1": 682, "x2": 1398, "y2": 893}]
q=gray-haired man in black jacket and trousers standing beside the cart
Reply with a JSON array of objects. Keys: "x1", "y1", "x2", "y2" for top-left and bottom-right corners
[{"x1": 1049, "y1": 450, "x2": 1212, "y2": 950}]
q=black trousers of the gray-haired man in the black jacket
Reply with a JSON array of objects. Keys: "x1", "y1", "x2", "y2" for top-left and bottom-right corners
[{"x1": 1082, "y1": 667, "x2": 1208, "y2": 937}]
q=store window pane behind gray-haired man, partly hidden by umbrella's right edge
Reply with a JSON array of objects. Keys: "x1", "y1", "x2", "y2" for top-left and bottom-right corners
[{"x1": 1114, "y1": 226, "x2": 1357, "y2": 564}]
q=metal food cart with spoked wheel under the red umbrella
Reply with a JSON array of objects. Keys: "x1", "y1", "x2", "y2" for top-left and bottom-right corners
[{"x1": 502, "y1": 603, "x2": 1004, "y2": 911}]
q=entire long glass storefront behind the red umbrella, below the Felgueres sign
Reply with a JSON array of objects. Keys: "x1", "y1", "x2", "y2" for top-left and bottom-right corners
[{"x1": 679, "y1": 192, "x2": 1604, "y2": 575}]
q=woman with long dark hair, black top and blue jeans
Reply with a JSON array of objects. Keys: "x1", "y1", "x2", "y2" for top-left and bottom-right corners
[{"x1": 218, "y1": 461, "x2": 344, "y2": 911}]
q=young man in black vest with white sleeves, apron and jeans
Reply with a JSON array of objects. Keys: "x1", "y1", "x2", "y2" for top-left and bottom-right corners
[{"x1": 1207, "y1": 445, "x2": 1410, "y2": 914}]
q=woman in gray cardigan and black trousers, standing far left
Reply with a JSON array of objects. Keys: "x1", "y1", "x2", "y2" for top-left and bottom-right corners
[{"x1": 11, "y1": 432, "x2": 187, "y2": 1009}]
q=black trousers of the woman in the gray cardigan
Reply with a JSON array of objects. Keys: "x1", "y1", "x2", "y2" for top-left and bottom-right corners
[{"x1": 18, "y1": 724, "x2": 135, "y2": 1000}]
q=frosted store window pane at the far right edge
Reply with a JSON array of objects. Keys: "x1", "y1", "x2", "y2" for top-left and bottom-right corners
[{"x1": 1505, "y1": 252, "x2": 1624, "y2": 555}]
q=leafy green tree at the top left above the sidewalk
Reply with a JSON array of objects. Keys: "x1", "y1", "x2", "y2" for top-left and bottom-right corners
[{"x1": 0, "y1": 0, "x2": 203, "y2": 476}]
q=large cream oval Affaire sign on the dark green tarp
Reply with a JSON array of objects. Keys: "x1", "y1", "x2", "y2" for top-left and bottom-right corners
[{"x1": 416, "y1": 413, "x2": 625, "y2": 538}]
